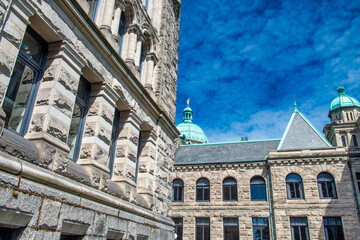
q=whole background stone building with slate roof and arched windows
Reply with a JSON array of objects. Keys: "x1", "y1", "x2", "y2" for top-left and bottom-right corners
[{"x1": 172, "y1": 86, "x2": 360, "y2": 240}]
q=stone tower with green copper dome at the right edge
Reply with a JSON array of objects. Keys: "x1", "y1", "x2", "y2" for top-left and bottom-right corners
[{"x1": 323, "y1": 84, "x2": 360, "y2": 147}]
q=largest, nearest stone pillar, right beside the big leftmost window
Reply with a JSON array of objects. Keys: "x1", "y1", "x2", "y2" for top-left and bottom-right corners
[{"x1": 25, "y1": 42, "x2": 85, "y2": 170}]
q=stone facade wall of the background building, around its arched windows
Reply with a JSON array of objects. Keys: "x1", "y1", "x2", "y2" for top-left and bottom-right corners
[{"x1": 172, "y1": 148, "x2": 360, "y2": 240}]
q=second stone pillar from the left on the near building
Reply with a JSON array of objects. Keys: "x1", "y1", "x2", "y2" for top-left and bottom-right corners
[{"x1": 77, "y1": 83, "x2": 115, "y2": 189}]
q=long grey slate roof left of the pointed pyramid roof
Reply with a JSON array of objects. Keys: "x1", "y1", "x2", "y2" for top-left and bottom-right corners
[{"x1": 174, "y1": 140, "x2": 280, "y2": 165}]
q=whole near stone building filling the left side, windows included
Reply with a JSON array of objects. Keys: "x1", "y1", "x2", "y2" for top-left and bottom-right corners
[{"x1": 0, "y1": 0, "x2": 180, "y2": 240}]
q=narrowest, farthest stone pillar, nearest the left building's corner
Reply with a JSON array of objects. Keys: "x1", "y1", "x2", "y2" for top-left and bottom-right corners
[{"x1": 137, "y1": 131, "x2": 157, "y2": 206}]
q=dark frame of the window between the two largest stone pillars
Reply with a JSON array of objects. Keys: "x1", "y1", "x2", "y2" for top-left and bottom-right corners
[{"x1": 67, "y1": 76, "x2": 91, "y2": 162}]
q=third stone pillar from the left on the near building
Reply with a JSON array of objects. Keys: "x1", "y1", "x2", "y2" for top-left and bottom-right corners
[{"x1": 111, "y1": 110, "x2": 141, "y2": 187}]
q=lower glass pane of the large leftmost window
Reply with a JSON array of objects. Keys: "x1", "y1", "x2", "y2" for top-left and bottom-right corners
[{"x1": 3, "y1": 60, "x2": 37, "y2": 132}]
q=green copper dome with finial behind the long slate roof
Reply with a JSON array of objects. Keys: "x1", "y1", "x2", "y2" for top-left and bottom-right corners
[{"x1": 177, "y1": 101, "x2": 208, "y2": 144}]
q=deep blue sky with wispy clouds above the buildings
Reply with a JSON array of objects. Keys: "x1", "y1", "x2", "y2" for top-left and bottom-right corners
[{"x1": 176, "y1": 0, "x2": 360, "y2": 142}]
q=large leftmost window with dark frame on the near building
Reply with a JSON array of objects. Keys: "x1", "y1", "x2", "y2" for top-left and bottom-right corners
[{"x1": 2, "y1": 27, "x2": 47, "y2": 136}]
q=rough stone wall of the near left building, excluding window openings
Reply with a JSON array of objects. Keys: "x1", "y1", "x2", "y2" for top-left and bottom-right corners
[{"x1": 0, "y1": 0, "x2": 180, "y2": 239}]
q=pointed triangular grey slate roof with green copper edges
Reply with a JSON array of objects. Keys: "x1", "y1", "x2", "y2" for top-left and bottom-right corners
[{"x1": 278, "y1": 108, "x2": 332, "y2": 150}]
